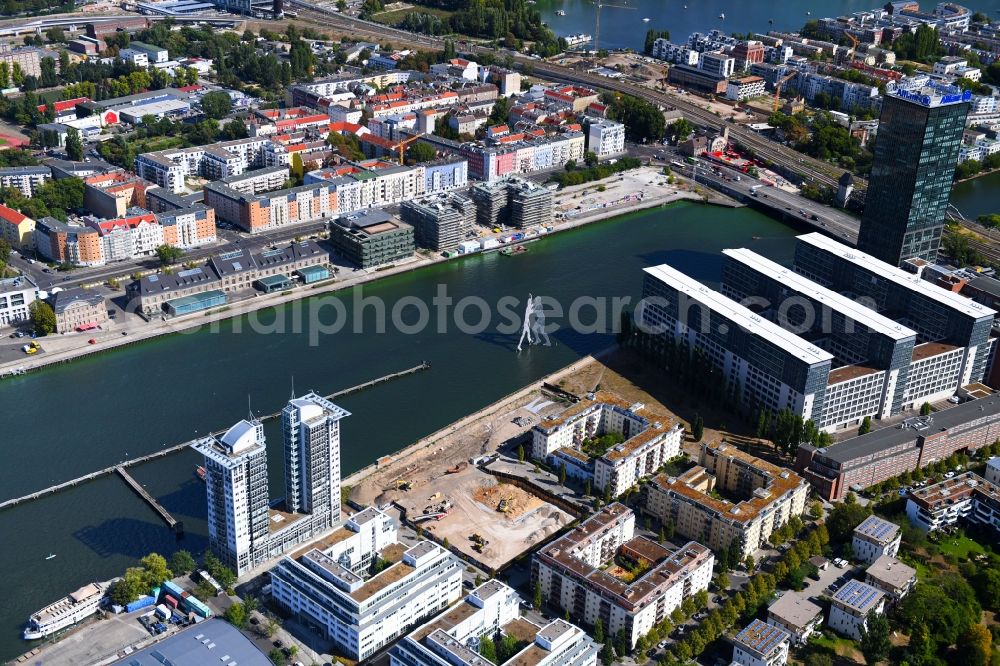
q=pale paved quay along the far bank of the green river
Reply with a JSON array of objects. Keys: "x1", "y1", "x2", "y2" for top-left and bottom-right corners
[{"x1": 0, "y1": 176, "x2": 704, "y2": 379}]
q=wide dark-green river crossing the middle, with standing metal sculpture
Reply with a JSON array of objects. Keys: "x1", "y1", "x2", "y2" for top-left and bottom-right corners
[{"x1": 0, "y1": 203, "x2": 794, "y2": 658}]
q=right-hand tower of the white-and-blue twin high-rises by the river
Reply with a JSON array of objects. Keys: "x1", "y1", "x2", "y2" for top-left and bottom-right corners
[{"x1": 281, "y1": 392, "x2": 350, "y2": 529}]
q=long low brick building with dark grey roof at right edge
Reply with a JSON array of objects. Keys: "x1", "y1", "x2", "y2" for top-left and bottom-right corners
[{"x1": 795, "y1": 396, "x2": 1000, "y2": 501}]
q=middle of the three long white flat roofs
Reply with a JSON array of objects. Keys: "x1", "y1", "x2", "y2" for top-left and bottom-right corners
[{"x1": 722, "y1": 248, "x2": 917, "y2": 340}]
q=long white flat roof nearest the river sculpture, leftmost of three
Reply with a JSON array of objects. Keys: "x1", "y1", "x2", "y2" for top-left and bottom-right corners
[{"x1": 643, "y1": 264, "x2": 836, "y2": 365}]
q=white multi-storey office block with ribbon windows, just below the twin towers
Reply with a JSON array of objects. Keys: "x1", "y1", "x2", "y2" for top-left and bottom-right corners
[{"x1": 270, "y1": 508, "x2": 465, "y2": 662}]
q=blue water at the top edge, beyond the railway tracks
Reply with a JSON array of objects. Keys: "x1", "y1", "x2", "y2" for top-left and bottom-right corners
[{"x1": 537, "y1": 0, "x2": 1000, "y2": 51}]
